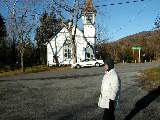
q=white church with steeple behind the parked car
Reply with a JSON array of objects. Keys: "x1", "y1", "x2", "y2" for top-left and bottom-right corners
[{"x1": 47, "y1": 0, "x2": 96, "y2": 66}]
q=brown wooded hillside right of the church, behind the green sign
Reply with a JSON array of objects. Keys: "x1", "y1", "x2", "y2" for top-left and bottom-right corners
[{"x1": 98, "y1": 29, "x2": 160, "y2": 62}]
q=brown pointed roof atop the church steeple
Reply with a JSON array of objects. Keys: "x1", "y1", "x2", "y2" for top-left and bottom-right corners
[{"x1": 83, "y1": 0, "x2": 97, "y2": 13}]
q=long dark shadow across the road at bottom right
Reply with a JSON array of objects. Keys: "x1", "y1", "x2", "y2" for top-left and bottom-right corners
[{"x1": 124, "y1": 86, "x2": 160, "y2": 120}]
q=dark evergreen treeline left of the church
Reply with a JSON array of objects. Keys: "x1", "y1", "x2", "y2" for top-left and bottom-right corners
[{"x1": 0, "y1": 12, "x2": 62, "y2": 70}]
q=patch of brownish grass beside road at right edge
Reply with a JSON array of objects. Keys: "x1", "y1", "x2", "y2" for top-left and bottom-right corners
[{"x1": 142, "y1": 66, "x2": 160, "y2": 89}]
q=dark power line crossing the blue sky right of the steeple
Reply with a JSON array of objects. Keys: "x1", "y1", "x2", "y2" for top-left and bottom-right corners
[{"x1": 95, "y1": 0, "x2": 145, "y2": 8}]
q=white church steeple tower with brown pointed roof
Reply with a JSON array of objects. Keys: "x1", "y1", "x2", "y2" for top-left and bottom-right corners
[{"x1": 82, "y1": 0, "x2": 97, "y2": 59}]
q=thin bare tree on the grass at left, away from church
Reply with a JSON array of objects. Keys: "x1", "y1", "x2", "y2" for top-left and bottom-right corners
[{"x1": 5, "y1": 0, "x2": 37, "y2": 72}]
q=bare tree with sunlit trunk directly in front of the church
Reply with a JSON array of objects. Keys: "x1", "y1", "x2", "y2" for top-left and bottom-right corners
[{"x1": 50, "y1": 0, "x2": 82, "y2": 63}]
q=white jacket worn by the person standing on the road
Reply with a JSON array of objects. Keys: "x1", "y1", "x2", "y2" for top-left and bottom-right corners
[{"x1": 98, "y1": 69, "x2": 120, "y2": 108}]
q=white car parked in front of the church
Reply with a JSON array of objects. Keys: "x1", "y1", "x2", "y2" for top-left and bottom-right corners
[{"x1": 71, "y1": 59, "x2": 104, "y2": 68}]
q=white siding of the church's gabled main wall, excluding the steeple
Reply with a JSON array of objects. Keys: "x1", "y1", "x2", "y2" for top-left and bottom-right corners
[{"x1": 47, "y1": 25, "x2": 94, "y2": 65}]
